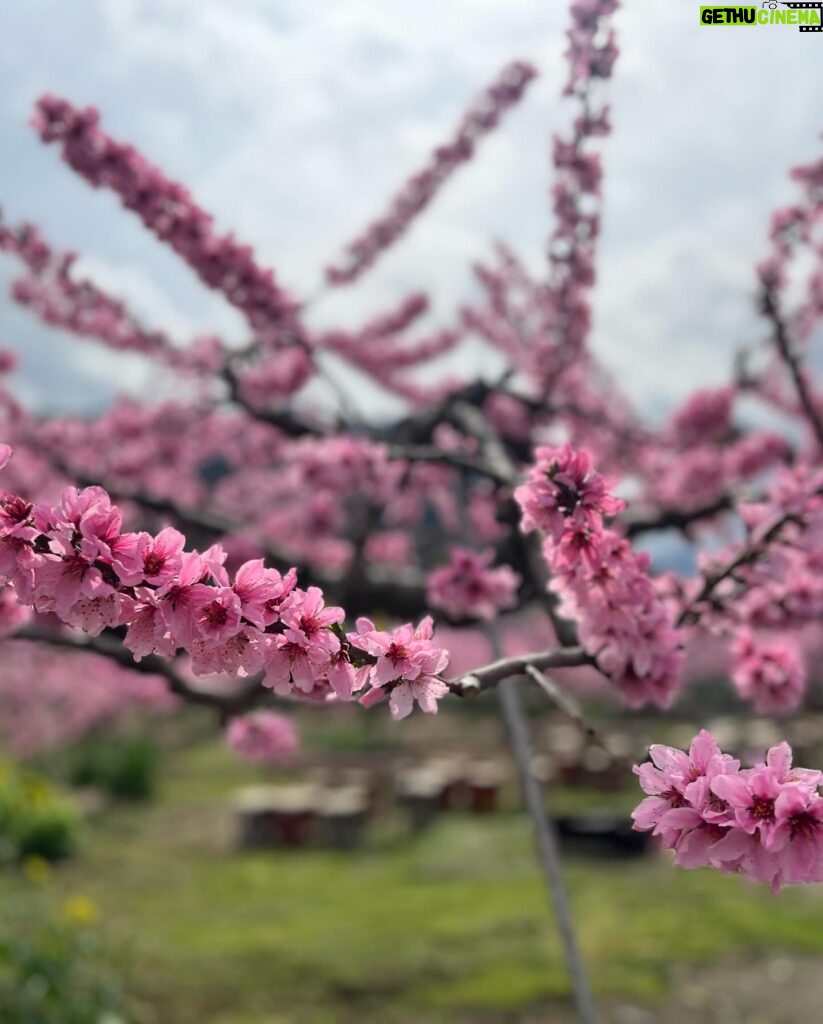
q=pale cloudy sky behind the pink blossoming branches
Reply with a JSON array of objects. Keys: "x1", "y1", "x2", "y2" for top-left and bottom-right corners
[{"x1": 0, "y1": 0, "x2": 823, "y2": 415}]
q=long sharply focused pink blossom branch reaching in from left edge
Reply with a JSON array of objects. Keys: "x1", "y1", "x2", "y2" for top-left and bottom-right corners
[{"x1": 0, "y1": 445, "x2": 448, "y2": 717}]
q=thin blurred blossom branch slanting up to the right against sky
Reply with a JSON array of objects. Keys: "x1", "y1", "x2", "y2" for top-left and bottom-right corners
[{"x1": 326, "y1": 61, "x2": 537, "y2": 285}]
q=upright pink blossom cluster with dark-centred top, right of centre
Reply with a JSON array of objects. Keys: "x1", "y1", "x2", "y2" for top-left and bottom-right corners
[{"x1": 515, "y1": 445, "x2": 684, "y2": 708}]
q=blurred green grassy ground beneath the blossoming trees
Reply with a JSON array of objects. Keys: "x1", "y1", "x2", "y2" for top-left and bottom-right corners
[{"x1": 0, "y1": 729, "x2": 823, "y2": 1024}]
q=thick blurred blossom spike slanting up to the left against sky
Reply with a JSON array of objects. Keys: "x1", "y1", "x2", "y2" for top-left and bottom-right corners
[{"x1": 34, "y1": 95, "x2": 296, "y2": 333}]
